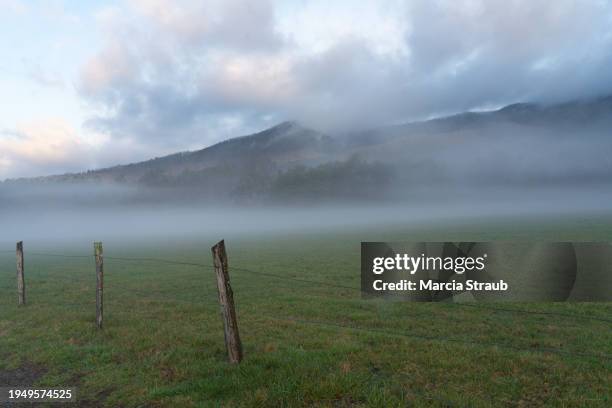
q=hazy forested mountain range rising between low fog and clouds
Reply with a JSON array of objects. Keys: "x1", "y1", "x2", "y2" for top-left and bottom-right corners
[{"x1": 4, "y1": 96, "x2": 612, "y2": 206}]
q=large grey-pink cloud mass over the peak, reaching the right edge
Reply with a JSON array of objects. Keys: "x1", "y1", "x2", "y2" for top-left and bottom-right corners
[{"x1": 78, "y1": 0, "x2": 612, "y2": 148}]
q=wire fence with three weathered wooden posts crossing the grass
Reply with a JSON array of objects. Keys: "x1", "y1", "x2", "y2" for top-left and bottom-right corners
[{"x1": 0, "y1": 241, "x2": 612, "y2": 363}]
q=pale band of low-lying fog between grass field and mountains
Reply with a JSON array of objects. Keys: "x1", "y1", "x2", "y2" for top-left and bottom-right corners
[{"x1": 0, "y1": 185, "x2": 612, "y2": 248}]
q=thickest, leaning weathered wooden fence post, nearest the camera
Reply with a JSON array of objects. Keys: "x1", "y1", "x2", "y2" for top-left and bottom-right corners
[{"x1": 212, "y1": 240, "x2": 242, "y2": 363}]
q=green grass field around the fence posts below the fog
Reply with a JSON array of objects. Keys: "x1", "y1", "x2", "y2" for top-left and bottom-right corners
[{"x1": 0, "y1": 216, "x2": 612, "y2": 407}]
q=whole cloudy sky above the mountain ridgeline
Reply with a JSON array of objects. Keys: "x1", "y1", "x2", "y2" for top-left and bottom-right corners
[{"x1": 0, "y1": 0, "x2": 612, "y2": 179}]
